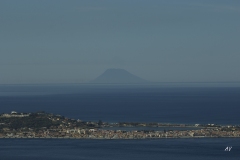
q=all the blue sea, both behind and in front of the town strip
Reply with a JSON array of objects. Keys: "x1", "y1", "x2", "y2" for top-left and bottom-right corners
[{"x1": 0, "y1": 83, "x2": 240, "y2": 160}]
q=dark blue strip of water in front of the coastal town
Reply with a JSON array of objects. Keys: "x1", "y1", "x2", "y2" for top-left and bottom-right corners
[{"x1": 0, "y1": 138, "x2": 240, "y2": 160}]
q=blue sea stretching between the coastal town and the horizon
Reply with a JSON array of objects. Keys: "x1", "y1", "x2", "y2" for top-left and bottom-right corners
[{"x1": 0, "y1": 85, "x2": 240, "y2": 124}]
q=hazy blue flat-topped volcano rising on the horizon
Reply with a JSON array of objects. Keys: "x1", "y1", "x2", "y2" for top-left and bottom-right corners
[{"x1": 91, "y1": 69, "x2": 148, "y2": 84}]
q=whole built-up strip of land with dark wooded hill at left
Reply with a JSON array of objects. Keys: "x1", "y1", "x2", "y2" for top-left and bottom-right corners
[{"x1": 0, "y1": 111, "x2": 240, "y2": 139}]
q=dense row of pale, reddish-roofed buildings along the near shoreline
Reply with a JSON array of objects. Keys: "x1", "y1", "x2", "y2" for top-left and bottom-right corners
[{"x1": 0, "y1": 127, "x2": 240, "y2": 139}]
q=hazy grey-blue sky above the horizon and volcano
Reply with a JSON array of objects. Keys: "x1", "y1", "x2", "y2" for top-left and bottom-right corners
[{"x1": 0, "y1": 0, "x2": 240, "y2": 84}]
